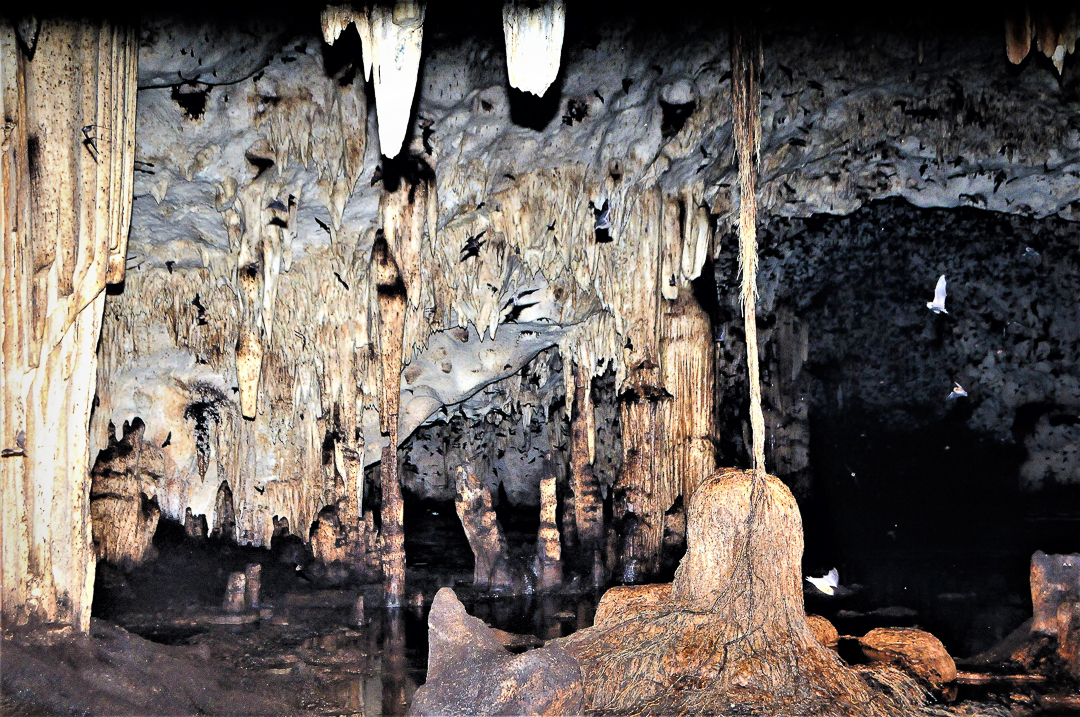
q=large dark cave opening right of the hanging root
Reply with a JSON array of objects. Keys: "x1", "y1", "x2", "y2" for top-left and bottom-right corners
[{"x1": 738, "y1": 200, "x2": 1080, "y2": 657}]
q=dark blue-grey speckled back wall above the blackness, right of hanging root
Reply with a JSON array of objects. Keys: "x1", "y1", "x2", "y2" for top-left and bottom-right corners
[{"x1": 738, "y1": 200, "x2": 1080, "y2": 490}]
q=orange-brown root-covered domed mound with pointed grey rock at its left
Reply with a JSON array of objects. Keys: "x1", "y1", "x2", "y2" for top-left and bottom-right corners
[{"x1": 410, "y1": 469, "x2": 927, "y2": 717}]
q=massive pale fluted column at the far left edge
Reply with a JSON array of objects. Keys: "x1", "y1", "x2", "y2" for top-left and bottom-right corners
[{"x1": 0, "y1": 19, "x2": 138, "y2": 632}]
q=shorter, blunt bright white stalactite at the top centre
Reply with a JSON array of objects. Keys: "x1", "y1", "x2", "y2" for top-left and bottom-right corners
[{"x1": 502, "y1": 0, "x2": 566, "y2": 97}]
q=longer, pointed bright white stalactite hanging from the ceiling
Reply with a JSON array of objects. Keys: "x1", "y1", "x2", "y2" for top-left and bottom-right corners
[{"x1": 367, "y1": 0, "x2": 424, "y2": 158}]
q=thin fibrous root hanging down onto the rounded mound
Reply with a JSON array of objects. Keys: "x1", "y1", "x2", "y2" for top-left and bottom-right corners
[{"x1": 731, "y1": 19, "x2": 765, "y2": 476}]
